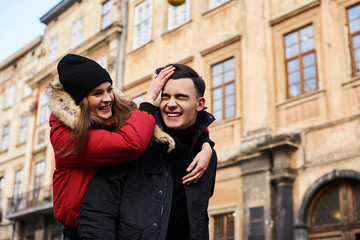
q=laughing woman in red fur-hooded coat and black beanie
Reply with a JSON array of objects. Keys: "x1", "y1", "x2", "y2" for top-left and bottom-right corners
[{"x1": 47, "y1": 54, "x2": 174, "y2": 239}]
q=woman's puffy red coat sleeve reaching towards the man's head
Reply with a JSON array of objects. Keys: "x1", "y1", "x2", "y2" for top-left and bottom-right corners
[{"x1": 50, "y1": 110, "x2": 155, "y2": 168}]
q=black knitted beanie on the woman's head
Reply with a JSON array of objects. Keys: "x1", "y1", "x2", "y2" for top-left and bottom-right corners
[{"x1": 57, "y1": 54, "x2": 112, "y2": 105}]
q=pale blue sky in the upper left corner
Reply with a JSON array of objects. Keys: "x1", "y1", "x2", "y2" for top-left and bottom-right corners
[{"x1": 0, "y1": 0, "x2": 61, "y2": 63}]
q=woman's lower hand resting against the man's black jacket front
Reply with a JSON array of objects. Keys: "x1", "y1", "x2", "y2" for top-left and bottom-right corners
[{"x1": 182, "y1": 142, "x2": 212, "y2": 185}]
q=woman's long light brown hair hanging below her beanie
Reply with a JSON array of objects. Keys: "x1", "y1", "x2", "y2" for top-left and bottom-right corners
[{"x1": 62, "y1": 93, "x2": 136, "y2": 157}]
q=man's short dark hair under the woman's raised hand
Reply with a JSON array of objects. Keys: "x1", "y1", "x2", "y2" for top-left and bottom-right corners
[{"x1": 155, "y1": 63, "x2": 205, "y2": 97}]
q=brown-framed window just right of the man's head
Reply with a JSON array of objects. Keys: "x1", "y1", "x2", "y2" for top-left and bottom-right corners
[{"x1": 211, "y1": 58, "x2": 235, "y2": 121}]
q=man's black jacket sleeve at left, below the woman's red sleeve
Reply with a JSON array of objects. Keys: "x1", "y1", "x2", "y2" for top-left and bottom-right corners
[{"x1": 76, "y1": 163, "x2": 130, "y2": 240}]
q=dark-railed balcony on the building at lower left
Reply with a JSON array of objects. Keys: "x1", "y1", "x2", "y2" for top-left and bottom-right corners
[{"x1": 6, "y1": 186, "x2": 53, "y2": 220}]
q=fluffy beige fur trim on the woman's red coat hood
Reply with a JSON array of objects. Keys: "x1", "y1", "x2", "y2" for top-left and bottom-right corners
[{"x1": 46, "y1": 79, "x2": 175, "y2": 152}]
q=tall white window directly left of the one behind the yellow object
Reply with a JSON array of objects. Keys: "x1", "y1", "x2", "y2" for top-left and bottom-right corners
[{"x1": 134, "y1": 0, "x2": 152, "y2": 48}]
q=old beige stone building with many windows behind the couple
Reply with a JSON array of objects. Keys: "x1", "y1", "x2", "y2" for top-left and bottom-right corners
[{"x1": 0, "y1": 0, "x2": 360, "y2": 240}]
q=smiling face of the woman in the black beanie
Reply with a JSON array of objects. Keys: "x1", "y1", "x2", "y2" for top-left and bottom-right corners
[{"x1": 87, "y1": 82, "x2": 114, "y2": 120}]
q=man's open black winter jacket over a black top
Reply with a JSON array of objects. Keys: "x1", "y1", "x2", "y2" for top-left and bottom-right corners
[{"x1": 77, "y1": 107, "x2": 217, "y2": 240}]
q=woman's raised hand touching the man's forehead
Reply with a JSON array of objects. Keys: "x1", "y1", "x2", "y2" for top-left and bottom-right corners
[{"x1": 144, "y1": 66, "x2": 175, "y2": 104}]
